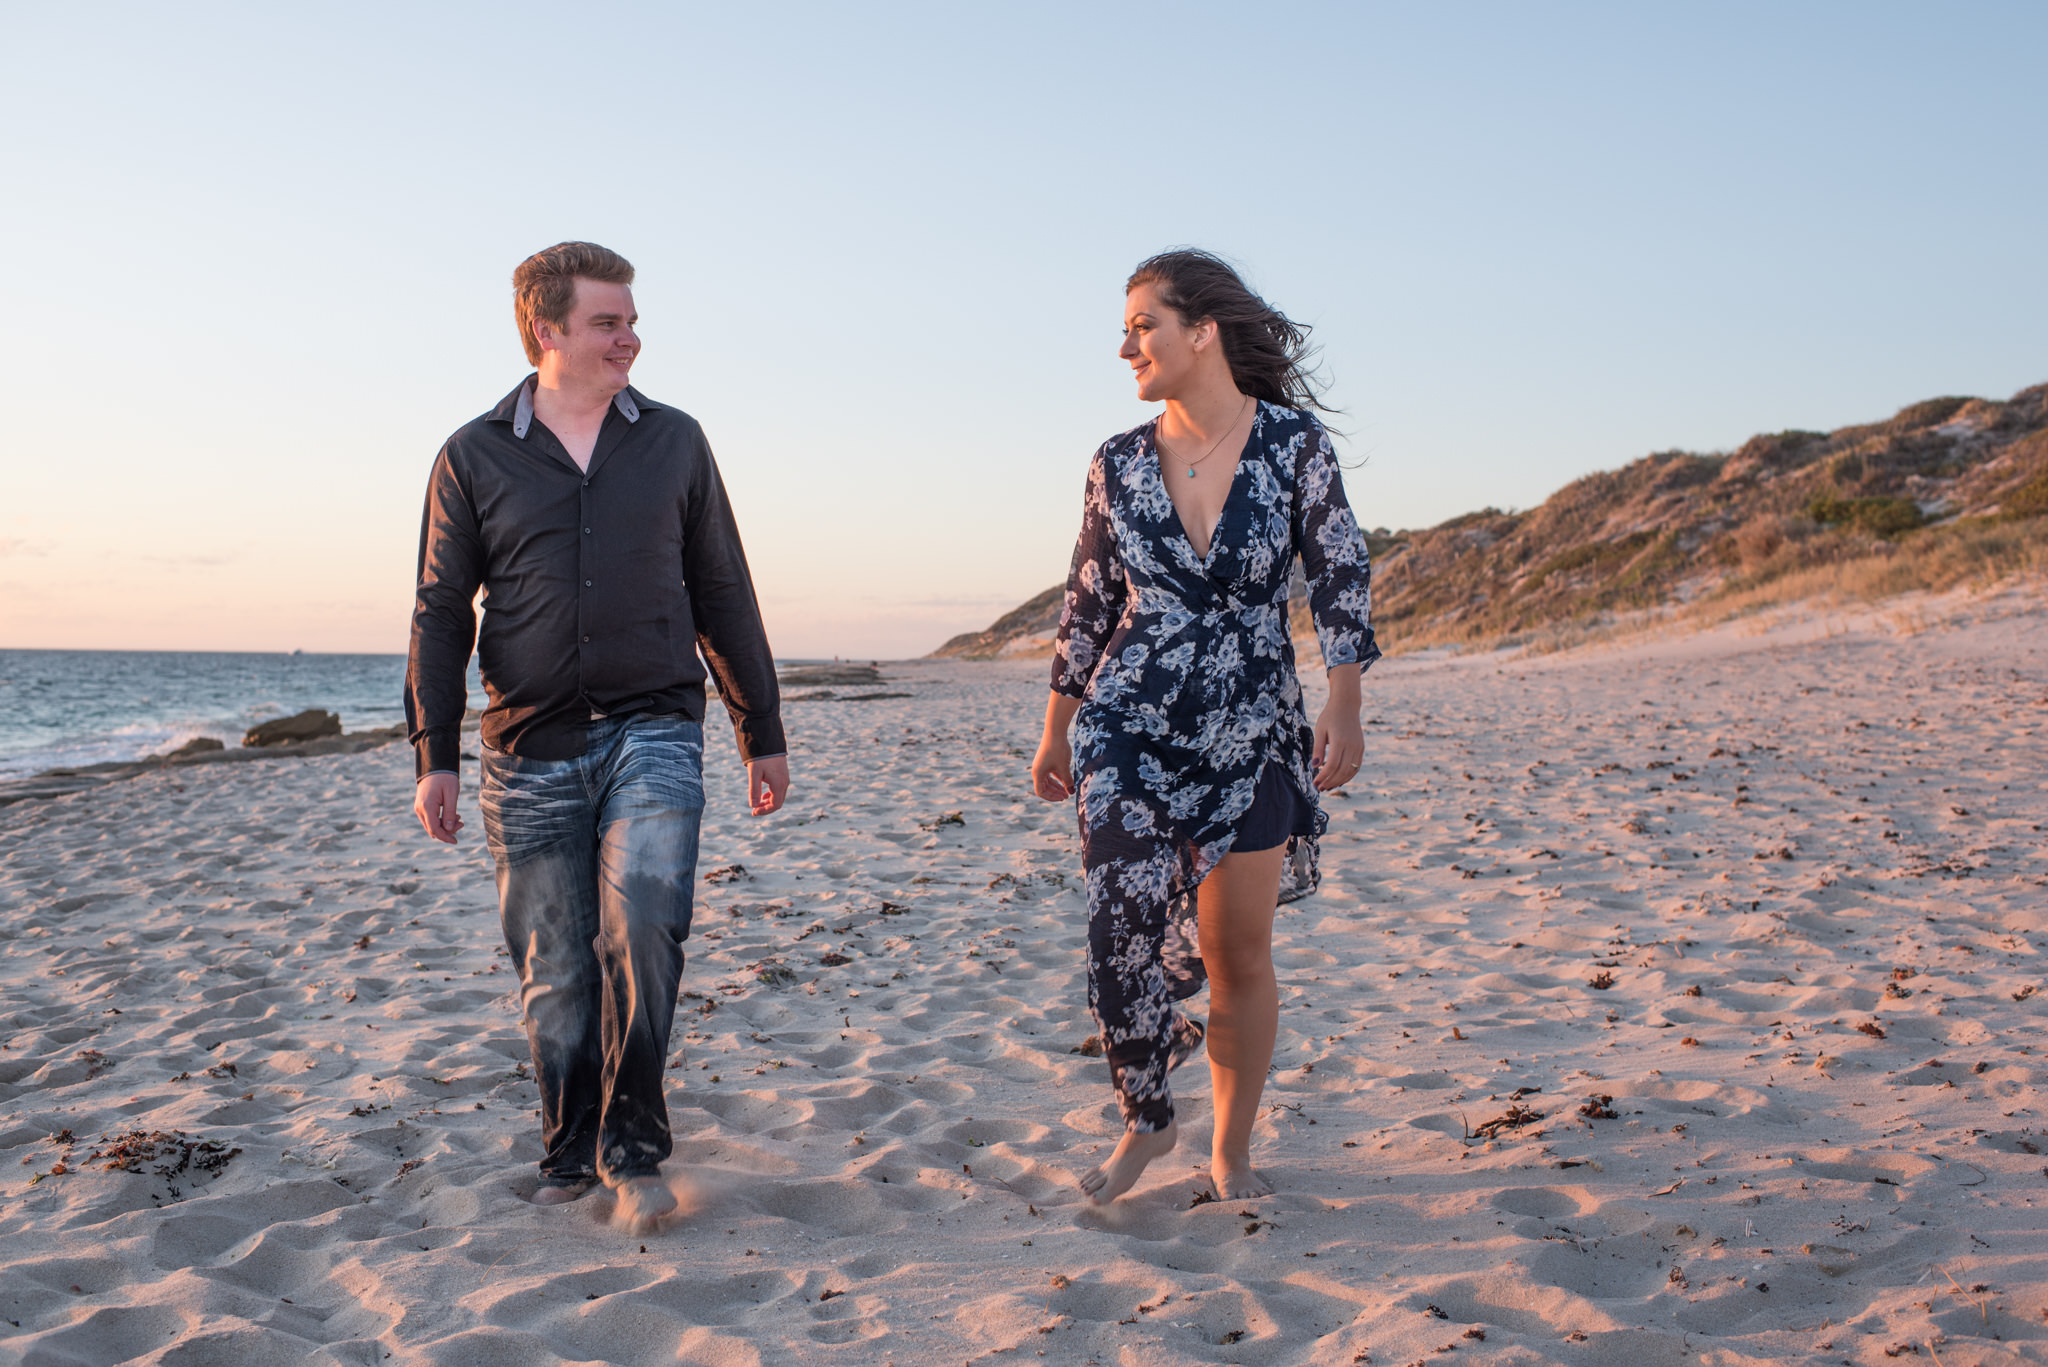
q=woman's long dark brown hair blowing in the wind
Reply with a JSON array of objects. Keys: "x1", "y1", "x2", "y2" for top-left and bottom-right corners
[{"x1": 1124, "y1": 246, "x2": 1333, "y2": 412}]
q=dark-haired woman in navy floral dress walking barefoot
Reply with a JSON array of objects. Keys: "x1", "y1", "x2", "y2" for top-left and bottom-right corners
[{"x1": 1032, "y1": 250, "x2": 1380, "y2": 1203}]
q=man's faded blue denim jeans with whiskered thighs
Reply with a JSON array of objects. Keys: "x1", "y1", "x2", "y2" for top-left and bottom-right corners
[{"x1": 479, "y1": 715, "x2": 705, "y2": 1185}]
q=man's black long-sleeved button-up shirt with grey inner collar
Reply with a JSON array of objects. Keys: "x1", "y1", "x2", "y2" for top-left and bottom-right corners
[{"x1": 406, "y1": 377, "x2": 784, "y2": 775}]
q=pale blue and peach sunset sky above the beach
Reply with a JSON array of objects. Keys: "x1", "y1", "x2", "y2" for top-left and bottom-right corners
[{"x1": 0, "y1": 4, "x2": 2048, "y2": 658}]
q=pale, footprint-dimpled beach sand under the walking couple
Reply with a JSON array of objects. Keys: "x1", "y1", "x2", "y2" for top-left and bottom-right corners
[{"x1": 0, "y1": 598, "x2": 2048, "y2": 1367}]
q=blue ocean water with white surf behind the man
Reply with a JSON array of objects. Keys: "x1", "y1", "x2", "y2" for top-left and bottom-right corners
[{"x1": 0, "y1": 650, "x2": 483, "y2": 777}]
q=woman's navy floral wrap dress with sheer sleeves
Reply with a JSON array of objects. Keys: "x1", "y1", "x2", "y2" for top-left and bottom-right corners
[{"x1": 1053, "y1": 402, "x2": 1380, "y2": 1131}]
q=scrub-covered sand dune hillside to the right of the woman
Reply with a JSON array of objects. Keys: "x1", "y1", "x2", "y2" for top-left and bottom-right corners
[{"x1": 1372, "y1": 385, "x2": 2048, "y2": 648}]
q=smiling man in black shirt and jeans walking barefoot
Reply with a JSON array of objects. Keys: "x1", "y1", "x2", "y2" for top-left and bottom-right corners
[{"x1": 406, "y1": 242, "x2": 788, "y2": 1226}]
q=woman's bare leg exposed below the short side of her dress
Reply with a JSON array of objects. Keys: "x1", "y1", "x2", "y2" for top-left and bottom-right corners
[{"x1": 1196, "y1": 846, "x2": 1286, "y2": 1201}]
